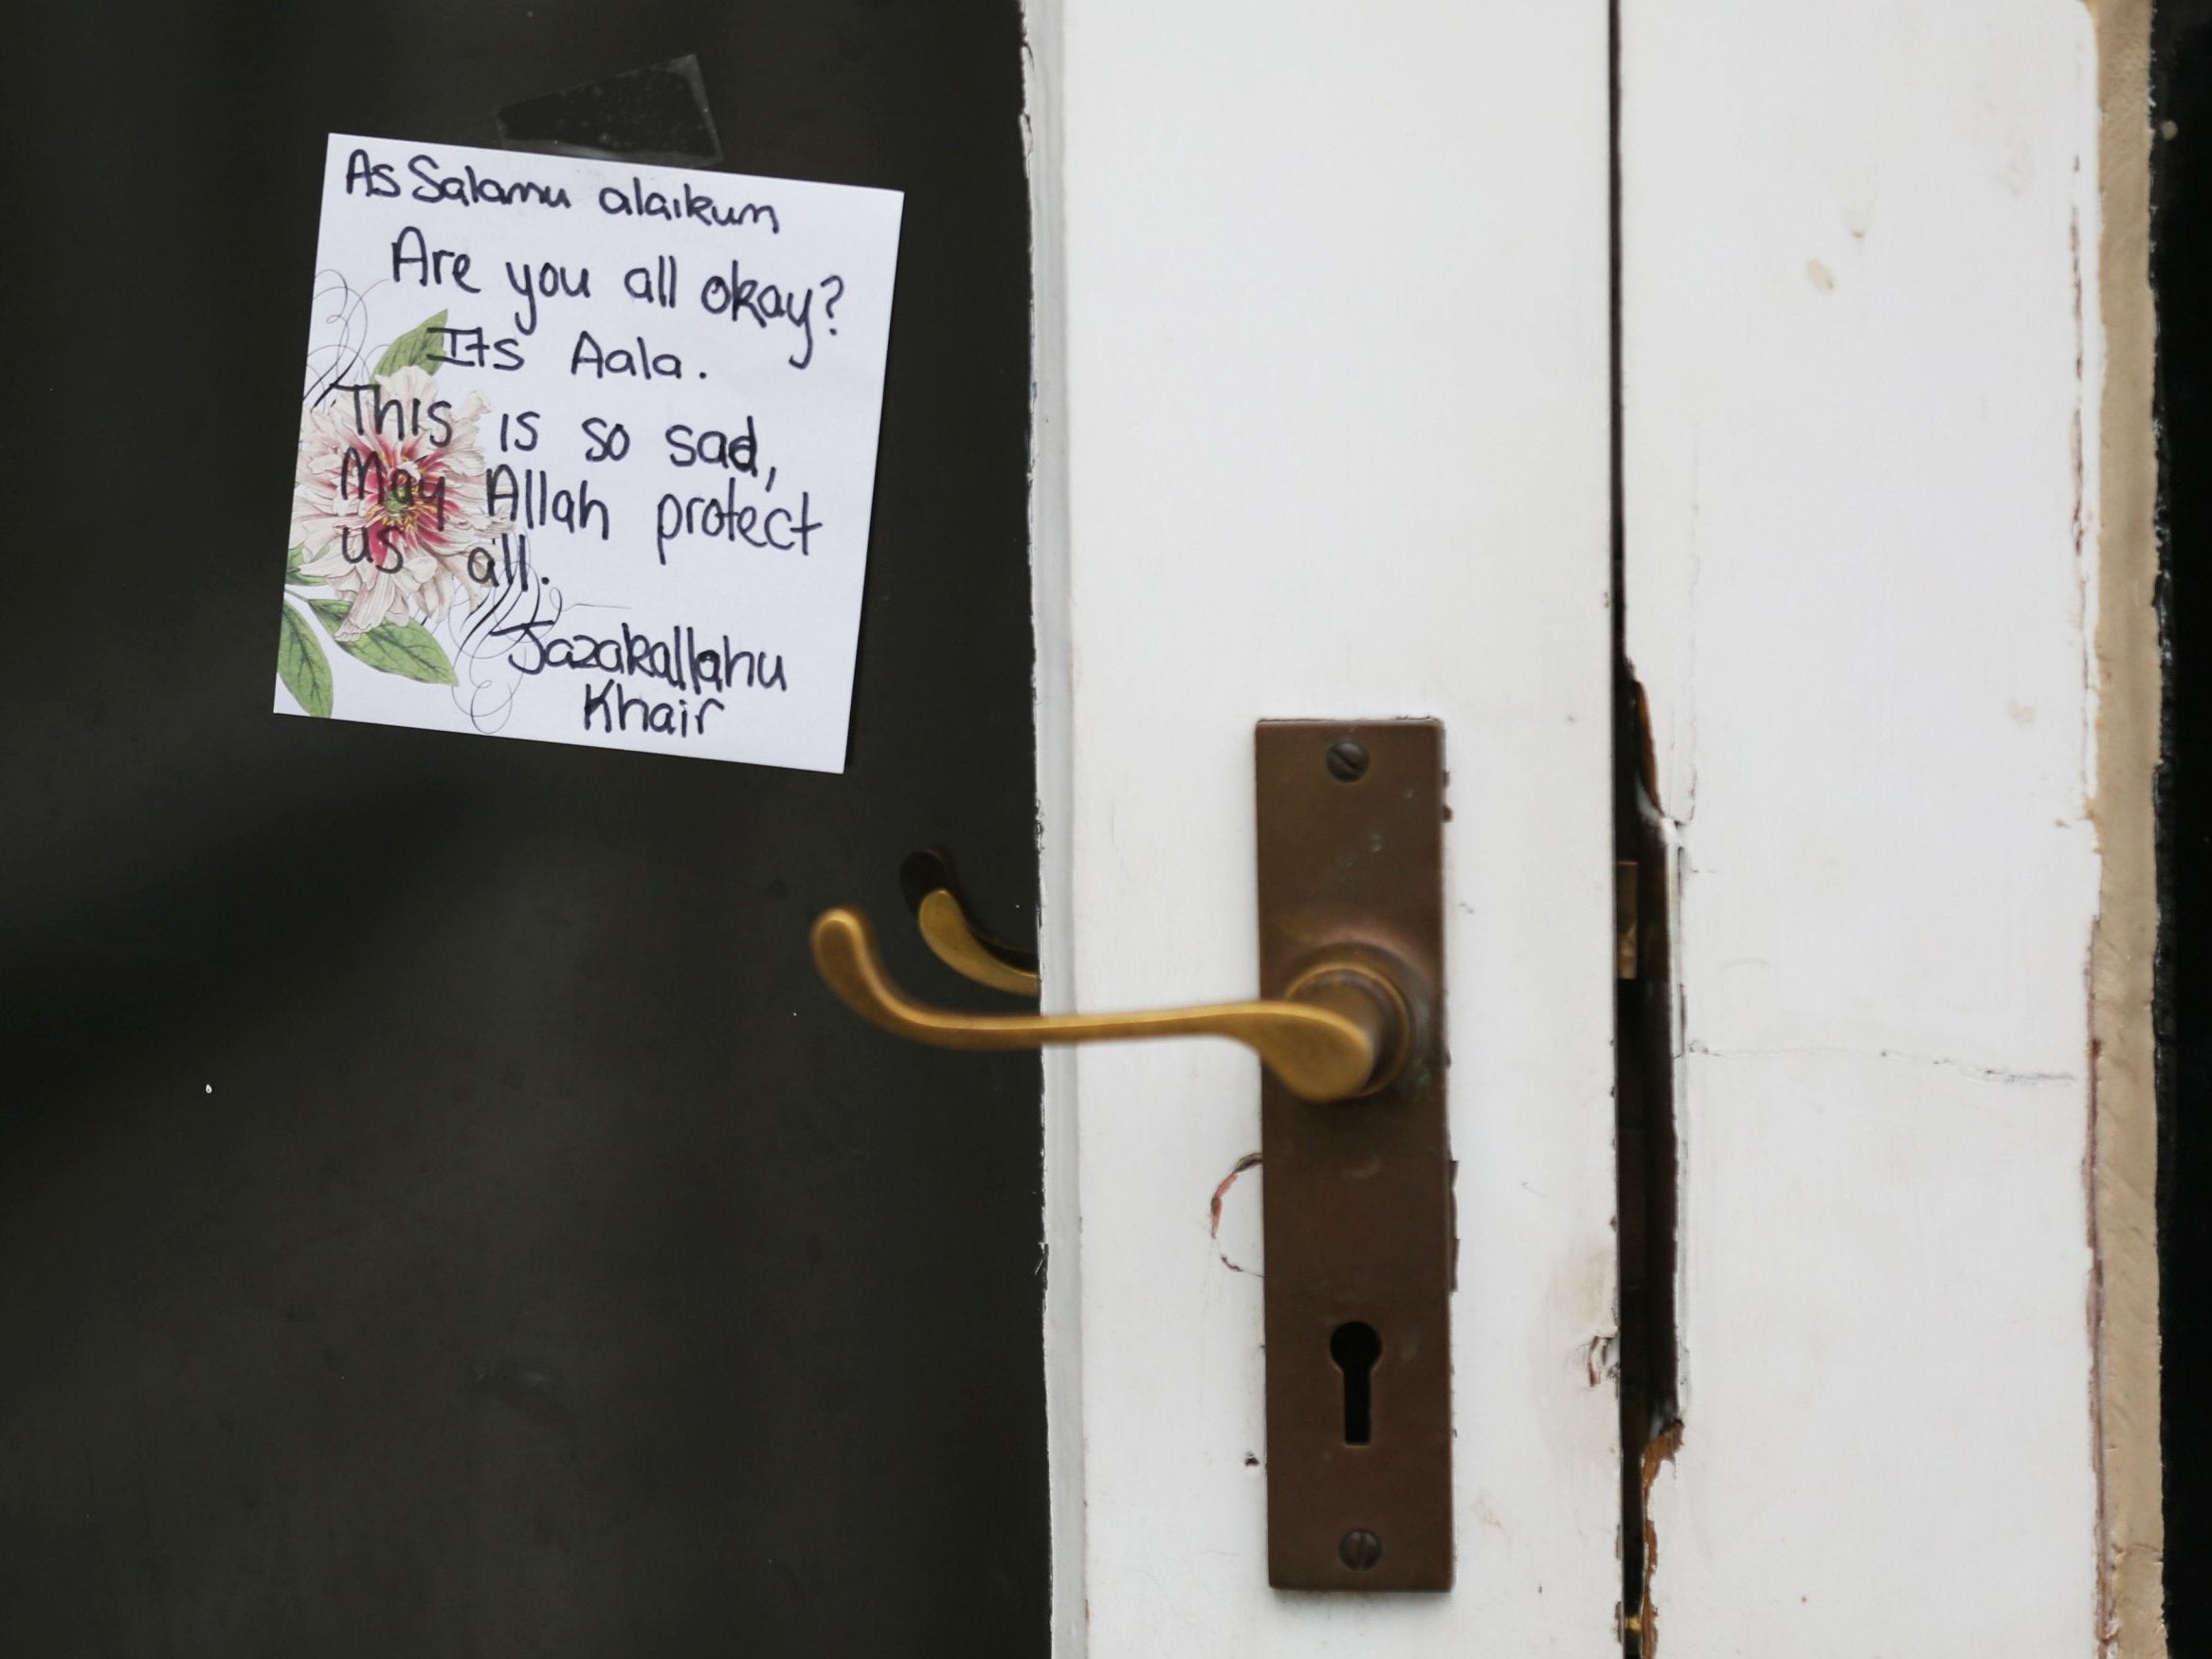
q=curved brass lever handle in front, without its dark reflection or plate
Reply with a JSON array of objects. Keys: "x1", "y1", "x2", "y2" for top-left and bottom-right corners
[{"x1": 814, "y1": 907, "x2": 1411, "y2": 1102}]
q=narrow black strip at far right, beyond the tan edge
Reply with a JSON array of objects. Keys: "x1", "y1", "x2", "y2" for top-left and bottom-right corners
[{"x1": 2150, "y1": 0, "x2": 2212, "y2": 1659}]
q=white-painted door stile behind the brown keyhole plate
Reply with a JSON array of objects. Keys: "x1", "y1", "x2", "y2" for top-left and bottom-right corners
[{"x1": 1031, "y1": 0, "x2": 1619, "y2": 1659}]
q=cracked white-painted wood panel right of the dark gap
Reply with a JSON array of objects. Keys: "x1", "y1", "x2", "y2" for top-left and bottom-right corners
[{"x1": 1622, "y1": 0, "x2": 2148, "y2": 1659}]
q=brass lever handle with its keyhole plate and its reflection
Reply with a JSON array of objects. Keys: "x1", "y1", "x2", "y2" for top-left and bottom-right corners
[{"x1": 812, "y1": 719, "x2": 1458, "y2": 1593}]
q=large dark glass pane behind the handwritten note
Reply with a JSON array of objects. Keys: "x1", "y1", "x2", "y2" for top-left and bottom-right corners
[{"x1": 0, "y1": 0, "x2": 1046, "y2": 1659}]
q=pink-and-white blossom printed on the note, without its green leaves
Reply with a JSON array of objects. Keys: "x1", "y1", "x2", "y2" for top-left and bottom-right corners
[{"x1": 292, "y1": 367, "x2": 513, "y2": 642}]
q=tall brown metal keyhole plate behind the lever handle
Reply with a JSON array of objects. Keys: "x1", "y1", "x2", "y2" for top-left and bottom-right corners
[{"x1": 1254, "y1": 721, "x2": 1456, "y2": 1591}]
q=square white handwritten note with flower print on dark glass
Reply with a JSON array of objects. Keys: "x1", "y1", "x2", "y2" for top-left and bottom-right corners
[{"x1": 277, "y1": 137, "x2": 900, "y2": 772}]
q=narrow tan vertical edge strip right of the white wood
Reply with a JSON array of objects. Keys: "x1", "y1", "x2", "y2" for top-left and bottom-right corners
[{"x1": 2086, "y1": 0, "x2": 2167, "y2": 1659}]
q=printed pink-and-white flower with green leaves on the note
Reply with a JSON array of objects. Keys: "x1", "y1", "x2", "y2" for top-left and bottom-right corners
[{"x1": 277, "y1": 312, "x2": 513, "y2": 717}]
